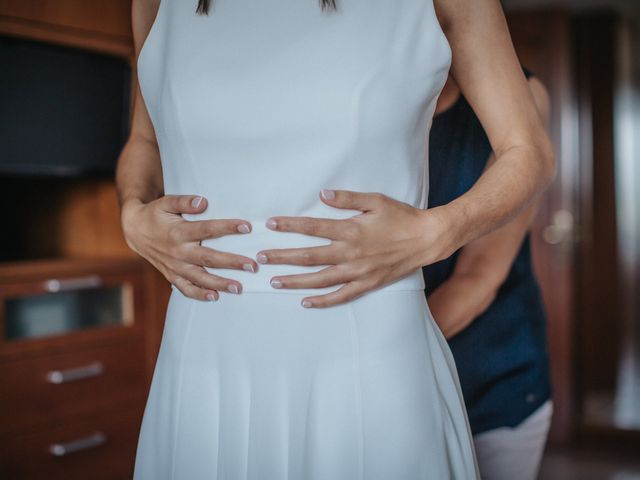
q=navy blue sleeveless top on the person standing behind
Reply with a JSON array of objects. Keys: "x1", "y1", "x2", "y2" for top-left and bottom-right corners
[{"x1": 423, "y1": 72, "x2": 551, "y2": 435}]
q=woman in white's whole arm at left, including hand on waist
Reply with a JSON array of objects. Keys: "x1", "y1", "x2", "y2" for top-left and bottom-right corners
[{"x1": 116, "y1": 0, "x2": 258, "y2": 301}]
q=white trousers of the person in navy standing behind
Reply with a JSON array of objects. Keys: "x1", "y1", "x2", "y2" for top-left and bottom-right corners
[{"x1": 473, "y1": 400, "x2": 553, "y2": 480}]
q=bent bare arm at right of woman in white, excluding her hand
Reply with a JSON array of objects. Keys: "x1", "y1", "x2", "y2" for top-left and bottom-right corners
[{"x1": 418, "y1": 0, "x2": 555, "y2": 265}]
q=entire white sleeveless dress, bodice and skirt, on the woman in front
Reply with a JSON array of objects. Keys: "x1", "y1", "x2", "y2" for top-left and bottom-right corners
[{"x1": 135, "y1": 0, "x2": 478, "y2": 480}]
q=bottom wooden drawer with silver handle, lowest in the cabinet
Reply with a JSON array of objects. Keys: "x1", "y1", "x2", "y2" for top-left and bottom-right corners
[{"x1": 0, "y1": 409, "x2": 142, "y2": 480}]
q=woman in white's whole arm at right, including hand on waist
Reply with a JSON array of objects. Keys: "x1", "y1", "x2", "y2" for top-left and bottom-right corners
[{"x1": 250, "y1": 0, "x2": 555, "y2": 308}]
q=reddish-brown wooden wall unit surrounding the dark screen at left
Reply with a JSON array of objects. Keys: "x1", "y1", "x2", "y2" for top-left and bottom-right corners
[{"x1": 0, "y1": 0, "x2": 171, "y2": 480}]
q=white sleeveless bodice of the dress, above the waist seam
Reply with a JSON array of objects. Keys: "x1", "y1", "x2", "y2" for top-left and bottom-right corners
[{"x1": 138, "y1": 0, "x2": 451, "y2": 292}]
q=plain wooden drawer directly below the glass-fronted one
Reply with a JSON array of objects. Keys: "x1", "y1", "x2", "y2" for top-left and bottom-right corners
[{"x1": 0, "y1": 341, "x2": 147, "y2": 433}]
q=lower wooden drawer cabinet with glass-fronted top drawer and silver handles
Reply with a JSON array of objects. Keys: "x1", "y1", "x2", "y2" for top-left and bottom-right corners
[{"x1": 0, "y1": 259, "x2": 157, "y2": 479}]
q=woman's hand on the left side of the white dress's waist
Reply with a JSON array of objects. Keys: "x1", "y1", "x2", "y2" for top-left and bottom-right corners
[{"x1": 122, "y1": 195, "x2": 258, "y2": 301}]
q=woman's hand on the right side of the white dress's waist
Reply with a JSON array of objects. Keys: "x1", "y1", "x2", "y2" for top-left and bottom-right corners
[{"x1": 256, "y1": 190, "x2": 457, "y2": 307}]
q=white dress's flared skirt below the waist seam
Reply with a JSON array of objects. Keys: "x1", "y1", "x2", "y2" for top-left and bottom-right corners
[{"x1": 134, "y1": 287, "x2": 477, "y2": 480}]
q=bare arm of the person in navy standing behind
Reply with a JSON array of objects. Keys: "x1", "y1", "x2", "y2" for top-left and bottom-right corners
[{"x1": 428, "y1": 77, "x2": 550, "y2": 338}]
